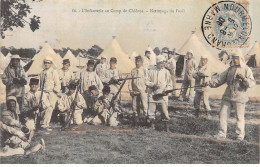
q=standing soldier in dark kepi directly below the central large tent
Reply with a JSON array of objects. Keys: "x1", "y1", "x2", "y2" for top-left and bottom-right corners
[{"x1": 104, "y1": 57, "x2": 121, "y2": 95}]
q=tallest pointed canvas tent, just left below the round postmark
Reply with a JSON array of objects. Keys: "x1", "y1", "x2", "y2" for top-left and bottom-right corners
[{"x1": 178, "y1": 32, "x2": 228, "y2": 73}]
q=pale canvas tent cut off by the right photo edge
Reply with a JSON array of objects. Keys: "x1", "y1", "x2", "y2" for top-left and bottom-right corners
[{"x1": 245, "y1": 41, "x2": 260, "y2": 67}]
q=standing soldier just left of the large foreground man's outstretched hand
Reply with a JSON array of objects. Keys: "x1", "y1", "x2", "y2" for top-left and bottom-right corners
[{"x1": 193, "y1": 55, "x2": 211, "y2": 117}]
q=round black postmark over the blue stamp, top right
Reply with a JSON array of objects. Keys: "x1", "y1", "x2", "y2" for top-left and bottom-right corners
[{"x1": 201, "y1": 1, "x2": 252, "y2": 49}]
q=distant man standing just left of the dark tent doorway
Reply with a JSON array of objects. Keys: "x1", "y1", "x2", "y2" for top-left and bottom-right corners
[{"x1": 166, "y1": 51, "x2": 176, "y2": 96}]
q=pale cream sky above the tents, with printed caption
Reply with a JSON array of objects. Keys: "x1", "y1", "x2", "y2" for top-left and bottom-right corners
[{"x1": 1, "y1": 0, "x2": 260, "y2": 54}]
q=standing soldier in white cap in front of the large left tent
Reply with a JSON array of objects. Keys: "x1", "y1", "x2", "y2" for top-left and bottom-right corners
[{"x1": 40, "y1": 57, "x2": 61, "y2": 125}]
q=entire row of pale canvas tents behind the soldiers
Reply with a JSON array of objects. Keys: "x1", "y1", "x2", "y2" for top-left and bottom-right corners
[{"x1": 0, "y1": 32, "x2": 260, "y2": 75}]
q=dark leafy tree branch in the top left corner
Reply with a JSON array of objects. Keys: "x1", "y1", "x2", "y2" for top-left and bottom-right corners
[{"x1": 0, "y1": 0, "x2": 42, "y2": 39}]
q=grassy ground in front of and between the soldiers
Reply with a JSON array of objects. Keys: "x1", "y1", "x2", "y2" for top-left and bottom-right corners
[{"x1": 0, "y1": 101, "x2": 259, "y2": 164}]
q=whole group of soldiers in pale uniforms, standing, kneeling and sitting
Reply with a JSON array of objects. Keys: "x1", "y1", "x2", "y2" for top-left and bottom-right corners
[{"x1": 0, "y1": 50, "x2": 255, "y2": 157}]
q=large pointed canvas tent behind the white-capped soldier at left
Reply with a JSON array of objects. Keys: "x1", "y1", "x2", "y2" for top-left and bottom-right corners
[{"x1": 27, "y1": 43, "x2": 62, "y2": 75}]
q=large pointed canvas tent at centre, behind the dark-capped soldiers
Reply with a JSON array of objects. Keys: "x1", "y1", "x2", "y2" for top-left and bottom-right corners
[{"x1": 98, "y1": 38, "x2": 135, "y2": 73}]
